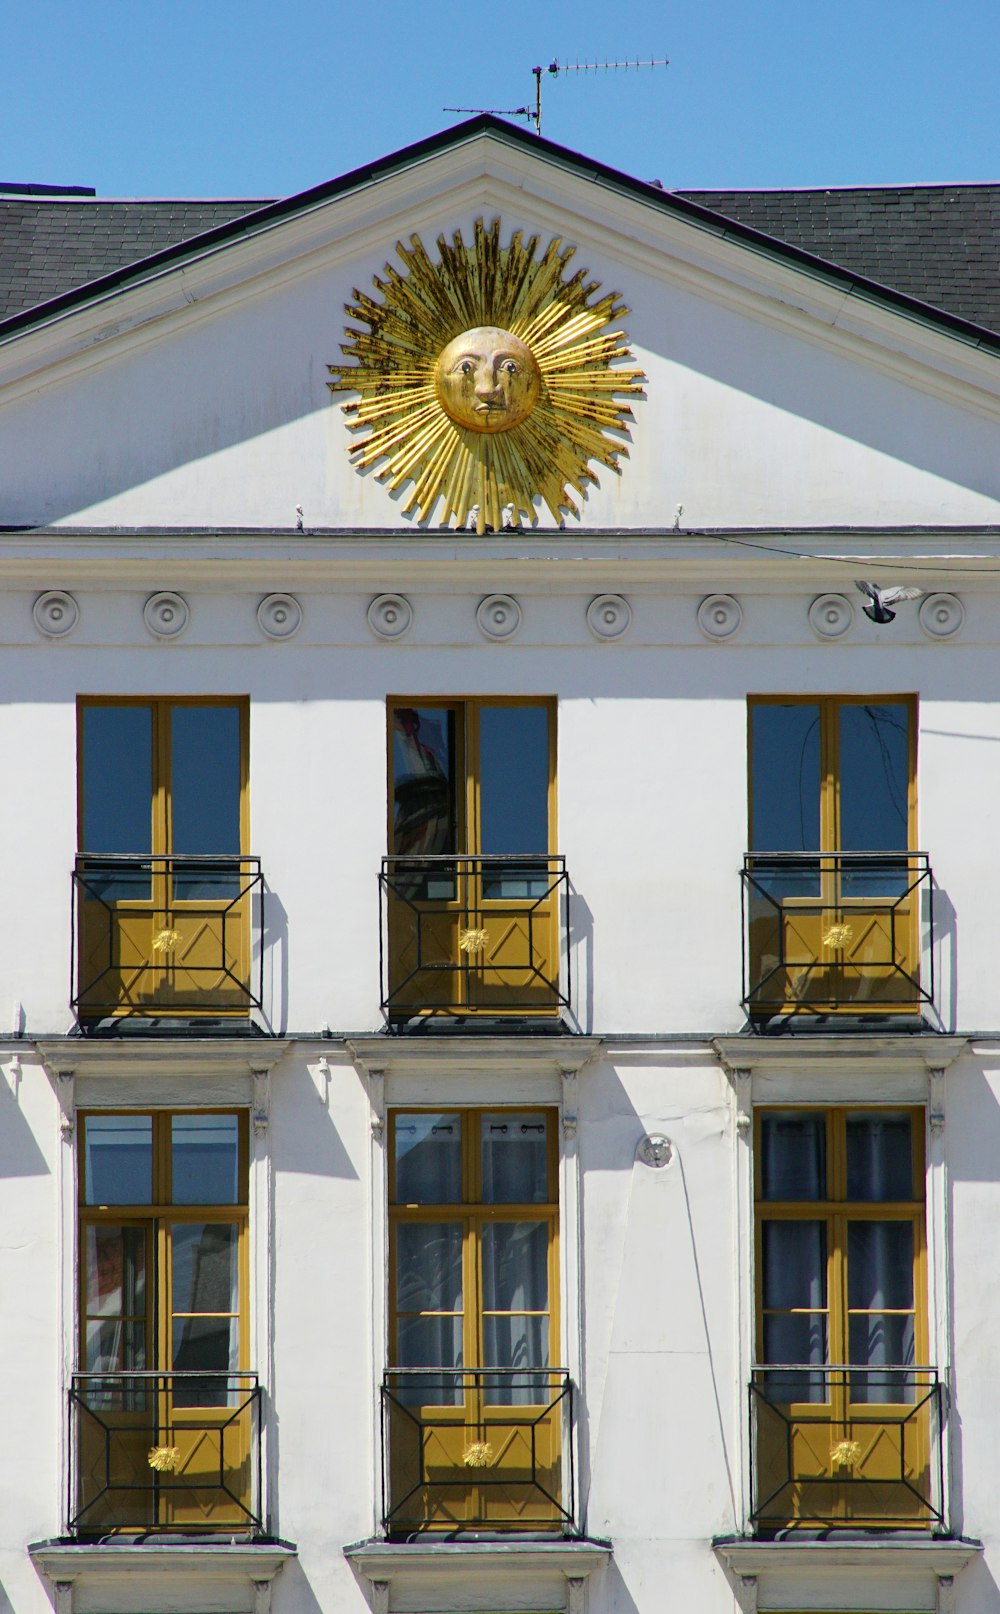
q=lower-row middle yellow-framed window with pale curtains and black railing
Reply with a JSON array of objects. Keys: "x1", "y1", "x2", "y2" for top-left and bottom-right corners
[{"x1": 382, "y1": 1109, "x2": 573, "y2": 1535}]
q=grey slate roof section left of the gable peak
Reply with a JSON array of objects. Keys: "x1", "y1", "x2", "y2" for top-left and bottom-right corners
[{"x1": 0, "y1": 194, "x2": 263, "y2": 320}]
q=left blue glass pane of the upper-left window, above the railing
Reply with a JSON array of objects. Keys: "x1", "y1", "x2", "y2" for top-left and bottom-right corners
[{"x1": 81, "y1": 705, "x2": 153, "y2": 852}]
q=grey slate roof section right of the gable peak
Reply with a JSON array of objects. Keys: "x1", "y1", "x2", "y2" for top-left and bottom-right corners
[{"x1": 677, "y1": 184, "x2": 1000, "y2": 332}]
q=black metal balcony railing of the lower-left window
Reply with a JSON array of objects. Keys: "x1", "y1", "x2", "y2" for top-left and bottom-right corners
[{"x1": 66, "y1": 1372, "x2": 263, "y2": 1535}]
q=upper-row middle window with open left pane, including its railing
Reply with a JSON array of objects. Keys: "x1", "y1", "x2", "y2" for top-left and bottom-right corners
[{"x1": 381, "y1": 699, "x2": 569, "y2": 1022}]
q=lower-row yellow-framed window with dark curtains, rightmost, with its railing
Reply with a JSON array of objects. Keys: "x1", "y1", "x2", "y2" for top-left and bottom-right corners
[{"x1": 750, "y1": 1109, "x2": 944, "y2": 1533}]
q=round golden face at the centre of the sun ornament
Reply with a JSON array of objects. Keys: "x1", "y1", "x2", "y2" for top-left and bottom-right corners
[{"x1": 434, "y1": 324, "x2": 542, "y2": 431}]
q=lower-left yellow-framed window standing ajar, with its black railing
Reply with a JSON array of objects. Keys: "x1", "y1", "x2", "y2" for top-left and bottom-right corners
[{"x1": 69, "y1": 1110, "x2": 260, "y2": 1535}]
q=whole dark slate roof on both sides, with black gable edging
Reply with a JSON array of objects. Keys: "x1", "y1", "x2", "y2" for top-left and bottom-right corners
[{"x1": 0, "y1": 122, "x2": 1000, "y2": 352}]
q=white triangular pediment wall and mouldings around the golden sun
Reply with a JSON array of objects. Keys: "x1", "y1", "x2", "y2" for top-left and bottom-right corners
[{"x1": 0, "y1": 119, "x2": 1000, "y2": 533}]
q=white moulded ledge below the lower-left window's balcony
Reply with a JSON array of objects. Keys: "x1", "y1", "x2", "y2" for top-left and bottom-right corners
[{"x1": 27, "y1": 1541, "x2": 297, "y2": 1614}]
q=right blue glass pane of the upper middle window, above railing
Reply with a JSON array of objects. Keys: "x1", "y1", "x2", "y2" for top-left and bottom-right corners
[{"x1": 479, "y1": 705, "x2": 548, "y2": 854}]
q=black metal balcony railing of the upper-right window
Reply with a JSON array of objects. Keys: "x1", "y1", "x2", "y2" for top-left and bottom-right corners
[{"x1": 740, "y1": 852, "x2": 934, "y2": 1015}]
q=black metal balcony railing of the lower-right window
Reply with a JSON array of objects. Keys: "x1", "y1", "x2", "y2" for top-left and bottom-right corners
[{"x1": 750, "y1": 1364, "x2": 945, "y2": 1533}]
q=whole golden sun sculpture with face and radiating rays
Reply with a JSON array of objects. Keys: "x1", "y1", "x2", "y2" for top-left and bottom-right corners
[{"x1": 329, "y1": 218, "x2": 645, "y2": 533}]
